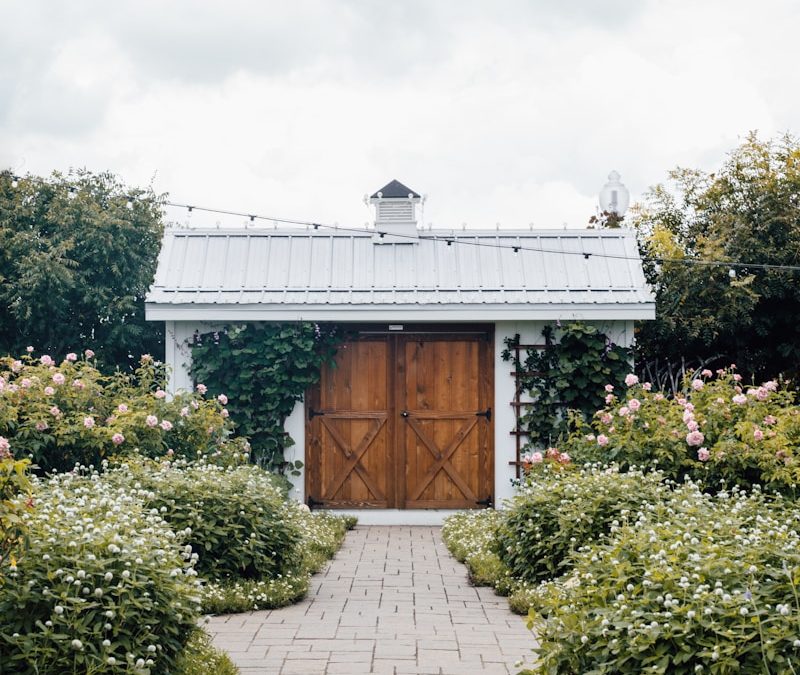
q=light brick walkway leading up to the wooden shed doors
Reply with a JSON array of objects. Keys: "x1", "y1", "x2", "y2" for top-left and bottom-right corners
[{"x1": 207, "y1": 526, "x2": 534, "y2": 675}]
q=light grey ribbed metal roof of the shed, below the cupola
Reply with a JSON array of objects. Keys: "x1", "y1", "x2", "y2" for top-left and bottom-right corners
[{"x1": 146, "y1": 229, "x2": 655, "y2": 321}]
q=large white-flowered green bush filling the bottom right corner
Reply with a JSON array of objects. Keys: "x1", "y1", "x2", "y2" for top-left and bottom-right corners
[{"x1": 530, "y1": 485, "x2": 800, "y2": 675}]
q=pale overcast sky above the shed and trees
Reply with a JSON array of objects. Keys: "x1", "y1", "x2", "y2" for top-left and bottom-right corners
[{"x1": 0, "y1": 0, "x2": 800, "y2": 227}]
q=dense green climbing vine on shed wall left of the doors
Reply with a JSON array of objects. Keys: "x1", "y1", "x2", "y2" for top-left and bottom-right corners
[{"x1": 190, "y1": 322, "x2": 342, "y2": 472}]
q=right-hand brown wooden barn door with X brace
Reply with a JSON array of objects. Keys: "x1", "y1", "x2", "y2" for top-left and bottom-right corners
[{"x1": 397, "y1": 335, "x2": 494, "y2": 509}]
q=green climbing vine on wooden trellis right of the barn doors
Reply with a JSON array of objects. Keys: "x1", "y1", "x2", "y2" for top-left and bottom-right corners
[{"x1": 502, "y1": 322, "x2": 631, "y2": 447}]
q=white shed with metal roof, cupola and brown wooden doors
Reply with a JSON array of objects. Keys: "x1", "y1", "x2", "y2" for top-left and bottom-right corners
[{"x1": 146, "y1": 181, "x2": 655, "y2": 524}]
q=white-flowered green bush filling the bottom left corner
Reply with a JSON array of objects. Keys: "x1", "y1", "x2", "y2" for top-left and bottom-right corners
[{"x1": 0, "y1": 474, "x2": 200, "y2": 675}]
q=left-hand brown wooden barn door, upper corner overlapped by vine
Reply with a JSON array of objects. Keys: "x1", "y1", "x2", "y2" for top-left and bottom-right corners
[{"x1": 306, "y1": 336, "x2": 395, "y2": 508}]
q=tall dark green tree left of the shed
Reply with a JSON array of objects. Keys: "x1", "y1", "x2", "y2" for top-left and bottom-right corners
[{"x1": 0, "y1": 171, "x2": 164, "y2": 368}]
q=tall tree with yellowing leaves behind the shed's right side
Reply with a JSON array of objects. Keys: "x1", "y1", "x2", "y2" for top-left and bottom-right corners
[{"x1": 633, "y1": 133, "x2": 800, "y2": 377}]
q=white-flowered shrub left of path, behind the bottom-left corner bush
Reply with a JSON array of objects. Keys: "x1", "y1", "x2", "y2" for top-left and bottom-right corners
[{"x1": 105, "y1": 459, "x2": 302, "y2": 580}]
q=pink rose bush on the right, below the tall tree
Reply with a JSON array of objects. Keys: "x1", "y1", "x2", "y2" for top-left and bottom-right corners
[{"x1": 564, "y1": 369, "x2": 800, "y2": 494}]
